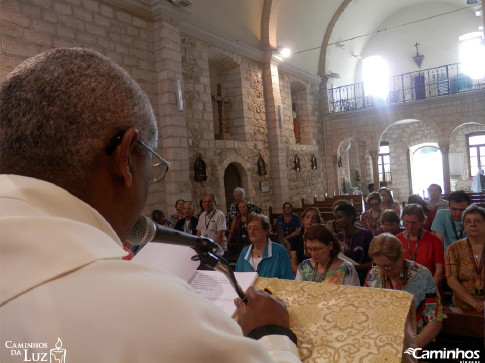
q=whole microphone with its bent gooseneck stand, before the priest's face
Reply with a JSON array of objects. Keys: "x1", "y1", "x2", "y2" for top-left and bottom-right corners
[{"x1": 127, "y1": 216, "x2": 248, "y2": 302}]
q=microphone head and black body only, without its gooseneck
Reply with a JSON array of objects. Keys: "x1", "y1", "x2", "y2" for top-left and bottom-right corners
[{"x1": 127, "y1": 216, "x2": 220, "y2": 254}]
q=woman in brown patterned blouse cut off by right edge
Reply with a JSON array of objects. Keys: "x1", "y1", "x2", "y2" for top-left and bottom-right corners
[{"x1": 445, "y1": 204, "x2": 485, "y2": 312}]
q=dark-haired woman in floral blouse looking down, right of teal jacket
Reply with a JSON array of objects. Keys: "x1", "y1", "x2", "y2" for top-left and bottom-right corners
[{"x1": 295, "y1": 224, "x2": 360, "y2": 286}]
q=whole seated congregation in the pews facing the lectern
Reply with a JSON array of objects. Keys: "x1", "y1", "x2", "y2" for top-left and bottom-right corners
[{"x1": 126, "y1": 184, "x2": 485, "y2": 348}]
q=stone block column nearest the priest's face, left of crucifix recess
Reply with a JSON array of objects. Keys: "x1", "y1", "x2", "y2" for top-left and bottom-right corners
[{"x1": 150, "y1": 19, "x2": 191, "y2": 212}]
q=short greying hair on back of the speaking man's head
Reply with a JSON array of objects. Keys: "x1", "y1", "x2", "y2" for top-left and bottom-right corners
[{"x1": 0, "y1": 48, "x2": 157, "y2": 188}]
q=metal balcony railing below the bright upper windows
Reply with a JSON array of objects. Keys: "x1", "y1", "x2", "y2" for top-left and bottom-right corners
[{"x1": 327, "y1": 63, "x2": 485, "y2": 113}]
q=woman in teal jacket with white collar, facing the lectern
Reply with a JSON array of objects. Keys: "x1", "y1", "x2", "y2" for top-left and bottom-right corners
[{"x1": 236, "y1": 214, "x2": 294, "y2": 280}]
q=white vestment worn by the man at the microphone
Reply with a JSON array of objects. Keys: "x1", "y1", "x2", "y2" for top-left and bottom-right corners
[{"x1": 0, "y1": 175, "x2": 299, "y2": 363}]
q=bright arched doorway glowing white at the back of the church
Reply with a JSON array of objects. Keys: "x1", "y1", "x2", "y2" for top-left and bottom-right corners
[{"x1": 410, "y1": 144, "x2": 444, "y2": 198}]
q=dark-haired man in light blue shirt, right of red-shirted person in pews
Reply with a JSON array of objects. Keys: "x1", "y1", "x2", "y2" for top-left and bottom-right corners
[{"x1": 431, "y1": 190, "x2": 470, "y2": 252}]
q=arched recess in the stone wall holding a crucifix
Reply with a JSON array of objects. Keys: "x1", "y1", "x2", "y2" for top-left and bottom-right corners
[{"x1": 207, "y1": 53, "x2": 245, "y2": 141}]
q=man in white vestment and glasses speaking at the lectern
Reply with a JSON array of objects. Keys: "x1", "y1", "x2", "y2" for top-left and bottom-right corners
[{"x1": 0, "y1": 48, "x2": 300, "y2": 363}]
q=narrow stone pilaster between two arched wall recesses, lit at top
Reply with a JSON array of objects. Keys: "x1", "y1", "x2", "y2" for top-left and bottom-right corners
[{"x1": 263, "y1": 50, "x2": 289, "y2": 206}]
